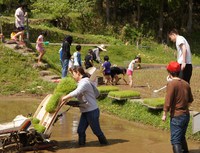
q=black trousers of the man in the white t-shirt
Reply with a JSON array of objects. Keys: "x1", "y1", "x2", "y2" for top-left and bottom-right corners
[{"x1": 179, "y1": 64, "x2": 193, "y2": 84}]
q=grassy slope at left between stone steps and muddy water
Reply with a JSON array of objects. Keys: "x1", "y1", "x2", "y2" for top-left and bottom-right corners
[{"x1": 0, "y1": 44, "x2": 55, "y2": 95}]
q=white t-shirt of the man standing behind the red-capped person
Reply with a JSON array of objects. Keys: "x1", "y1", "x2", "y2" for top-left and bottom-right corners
[{"x1": 176, "y1": 35, "x2": 192, "y2": 64}]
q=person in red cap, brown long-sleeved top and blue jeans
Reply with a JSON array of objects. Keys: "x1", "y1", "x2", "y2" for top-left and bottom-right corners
[{"x1": 162, "y1": 61, "x2": 193, "y2": 153}]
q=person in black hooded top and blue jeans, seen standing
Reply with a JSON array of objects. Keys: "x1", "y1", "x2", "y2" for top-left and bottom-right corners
[{"x1": 61, "y1": 35, "x2": 73, "y2": 78}]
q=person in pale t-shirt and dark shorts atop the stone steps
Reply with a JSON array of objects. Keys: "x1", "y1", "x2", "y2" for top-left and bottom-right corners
[{"x1": 12, "y1": 4, "x2": 27, "y2": 42}]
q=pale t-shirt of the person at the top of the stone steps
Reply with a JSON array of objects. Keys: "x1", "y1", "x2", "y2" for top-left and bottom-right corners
[{"x1": 15, "y1": 7, "x2": 24, "y2": 28}]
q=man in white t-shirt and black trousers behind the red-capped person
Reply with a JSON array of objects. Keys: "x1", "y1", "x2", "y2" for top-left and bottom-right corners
[{"x1": 169, "y1": 29, "x2": 192, "y2": 83}]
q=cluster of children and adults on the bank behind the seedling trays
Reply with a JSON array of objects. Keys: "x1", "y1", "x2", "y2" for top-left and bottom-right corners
[{"x1": 59, "y1": 36, "x2": 141, "y2": 87}]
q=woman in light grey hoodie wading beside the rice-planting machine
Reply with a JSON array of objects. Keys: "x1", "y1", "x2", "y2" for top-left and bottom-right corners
[{"x1": 62, "y1": 67, "x2": 108, "y2": 145}]
